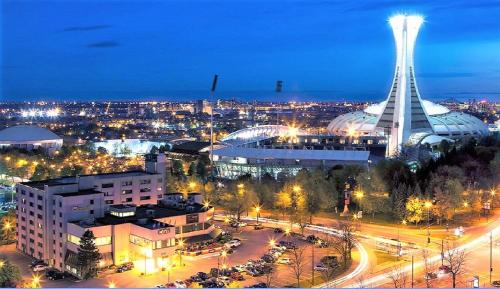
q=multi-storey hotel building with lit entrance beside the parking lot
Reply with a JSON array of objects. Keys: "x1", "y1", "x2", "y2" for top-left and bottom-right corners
[{"x1": 16, "y1": 156, "x2": 214, "y2": 275}]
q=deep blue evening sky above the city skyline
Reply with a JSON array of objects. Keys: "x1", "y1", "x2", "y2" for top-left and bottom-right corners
[{"x1": 0, "y1": 0, "x2": 500, "y2": 100}]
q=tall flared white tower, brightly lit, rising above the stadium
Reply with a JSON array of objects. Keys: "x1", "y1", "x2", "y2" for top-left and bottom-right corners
[{"x1": 376, "y1": 15, "x2": 433, "y2": 155}]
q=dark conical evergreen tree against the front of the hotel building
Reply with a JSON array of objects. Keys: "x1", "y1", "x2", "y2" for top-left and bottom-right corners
[{"x1": 77, "y1": 230, "x2": 101, "y2": 279}]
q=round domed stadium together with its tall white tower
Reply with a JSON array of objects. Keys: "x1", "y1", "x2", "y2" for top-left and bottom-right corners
[{"x1": 328, "y1": 15, "x2": 488, "y2": 156}]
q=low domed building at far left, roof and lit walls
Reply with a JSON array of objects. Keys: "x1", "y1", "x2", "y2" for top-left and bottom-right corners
[{"x1": 0, "y1": 125, "x2": 63, "y2": 152}]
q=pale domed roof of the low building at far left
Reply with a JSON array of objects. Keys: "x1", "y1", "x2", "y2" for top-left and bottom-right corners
[{"x1": 0, "y1": 125, "x2": 61, "y2": 142}]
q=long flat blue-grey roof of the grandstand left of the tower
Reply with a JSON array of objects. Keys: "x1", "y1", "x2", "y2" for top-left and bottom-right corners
[{"x1": 213, "y1": 147, "x2": 370, "y2": 161}]
